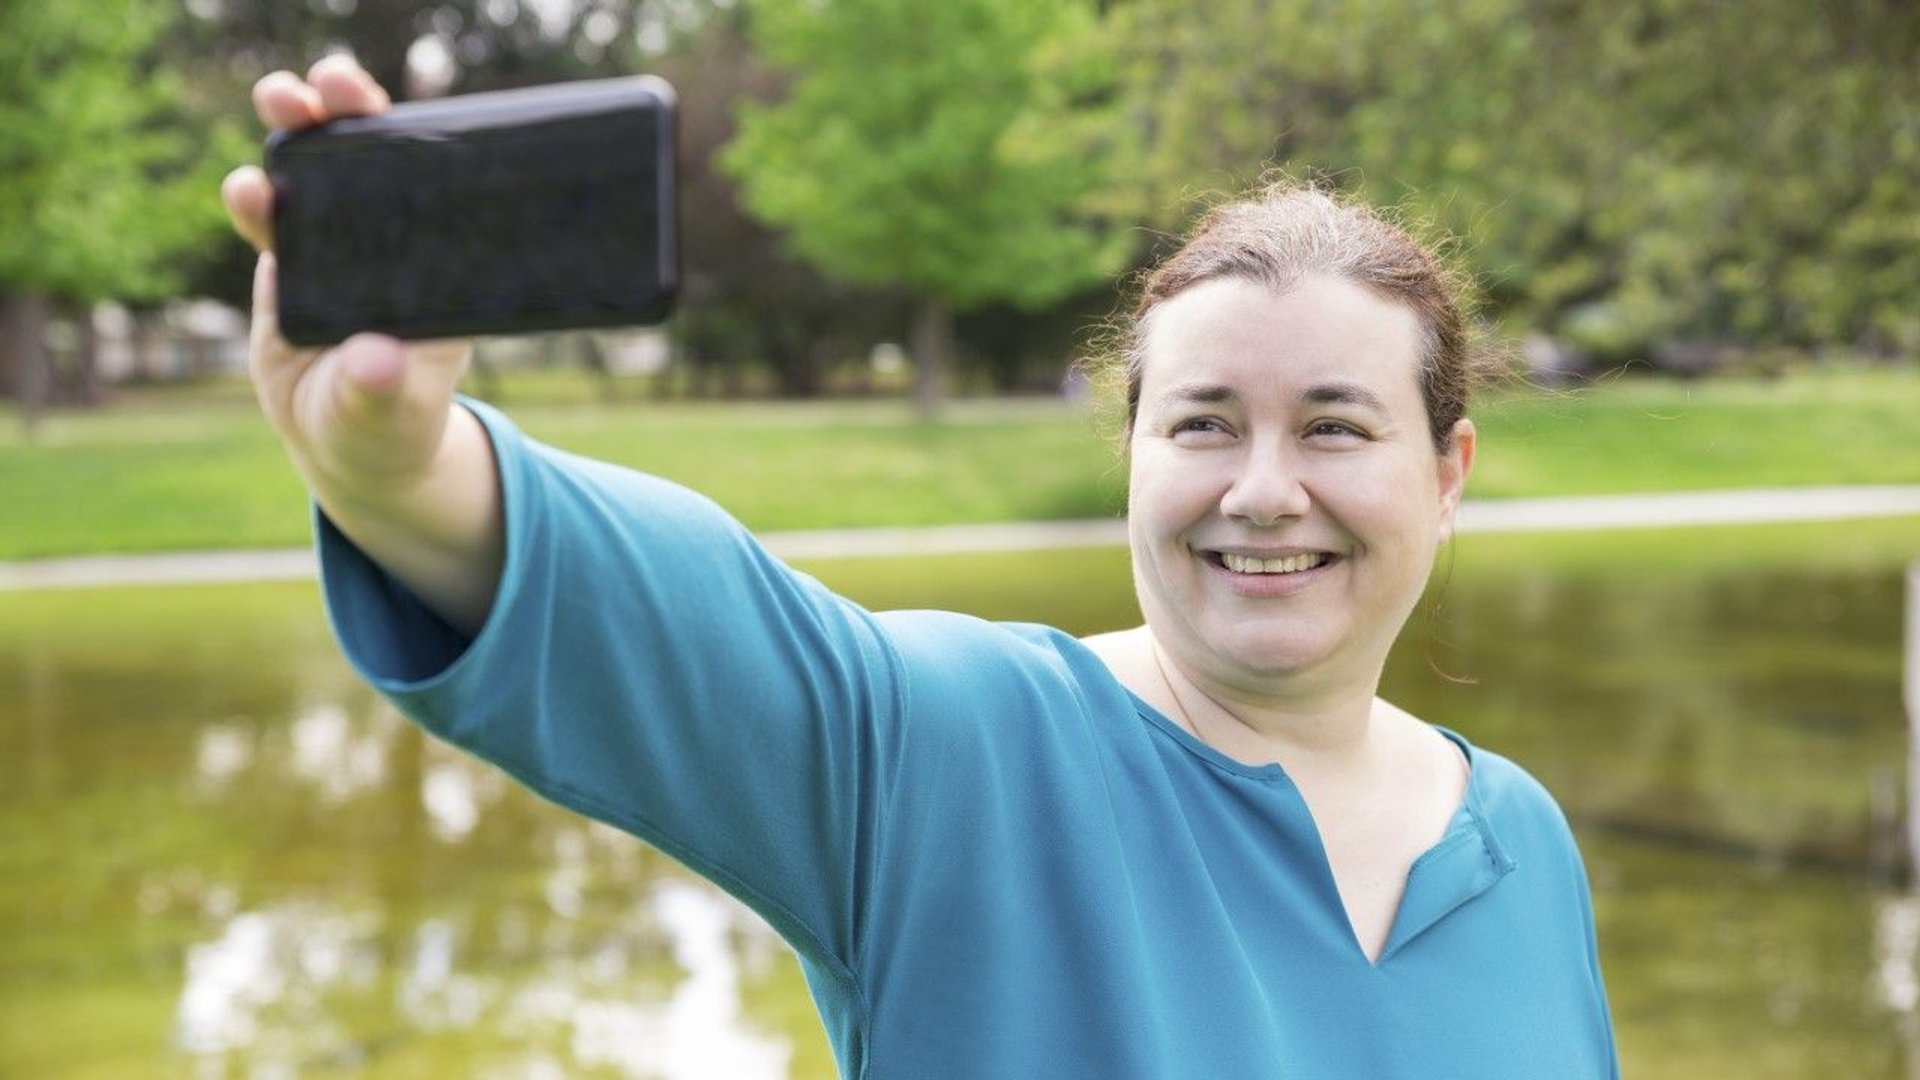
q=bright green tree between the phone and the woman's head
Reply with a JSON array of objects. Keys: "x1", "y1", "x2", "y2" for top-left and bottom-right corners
[{"x1": 724, "y1": 0, "x2": 1129, "y2": 413}]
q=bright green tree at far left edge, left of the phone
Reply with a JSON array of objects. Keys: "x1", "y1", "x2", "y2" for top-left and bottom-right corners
[{"x1": 0, "y1": 0, "x2": 234, "y2": 425}]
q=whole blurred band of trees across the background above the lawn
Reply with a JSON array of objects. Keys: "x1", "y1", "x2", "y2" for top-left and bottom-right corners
[{"x1": 0, "y1": 0, "x2": 1920, "y2": 409}]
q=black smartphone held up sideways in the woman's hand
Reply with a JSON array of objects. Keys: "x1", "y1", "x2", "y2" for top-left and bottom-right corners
[{"x1": 267, "y1": 75, "x2": 680, "y2": 346}]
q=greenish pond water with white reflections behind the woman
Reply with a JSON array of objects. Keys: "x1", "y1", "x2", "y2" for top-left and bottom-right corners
[{"x1": 0, "y1": 521, "x2": 1920, "y2": 1080}]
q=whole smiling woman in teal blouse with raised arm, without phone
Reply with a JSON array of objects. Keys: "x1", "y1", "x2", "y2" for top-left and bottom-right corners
[{"x1": 225, "y1": 60, "x2": 1617, "y2": 1080}]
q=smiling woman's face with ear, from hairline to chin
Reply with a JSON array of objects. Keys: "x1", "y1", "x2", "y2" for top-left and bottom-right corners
[{"x1": 1127, "y1": 275, "x2": 1473, "y2": 694}]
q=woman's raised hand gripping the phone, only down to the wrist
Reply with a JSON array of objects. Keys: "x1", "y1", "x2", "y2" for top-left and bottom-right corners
[{"x1": 221, "y1": 56, "x2": 472, "y2": 503}]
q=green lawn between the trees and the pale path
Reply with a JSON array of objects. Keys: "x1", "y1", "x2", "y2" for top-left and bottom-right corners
[{"x1": 0, "y1": 371, "x2": 1920, "y2": 559}]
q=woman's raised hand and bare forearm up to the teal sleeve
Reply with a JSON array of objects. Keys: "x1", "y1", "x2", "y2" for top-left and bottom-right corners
[{"x1": 221, "y1": 56, "x2": 505, "y2": 632}]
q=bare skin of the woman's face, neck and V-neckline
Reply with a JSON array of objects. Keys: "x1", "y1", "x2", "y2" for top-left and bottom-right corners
[{"x1": 1096, "y1": 275, "x2": 1473, "y2": 957}]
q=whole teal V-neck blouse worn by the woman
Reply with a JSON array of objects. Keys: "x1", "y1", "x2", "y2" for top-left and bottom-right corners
[{"x1": 319, "y1": 404, "x2": 1619, "y2": 1080}]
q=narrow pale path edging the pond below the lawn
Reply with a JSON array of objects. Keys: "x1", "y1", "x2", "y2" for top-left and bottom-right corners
[{"x1": 0, "y1": 484, "x2": 1920, "y2": 592}]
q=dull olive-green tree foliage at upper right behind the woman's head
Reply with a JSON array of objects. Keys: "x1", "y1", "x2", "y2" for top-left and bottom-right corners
[{"x1": 1104, "y1": 0, "x2": 1920, "y2": 354}]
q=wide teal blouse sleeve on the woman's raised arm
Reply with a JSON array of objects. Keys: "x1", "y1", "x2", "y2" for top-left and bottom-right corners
[{"x1": 317, "y1": 402, "x2": 904, "y2": 970}]
